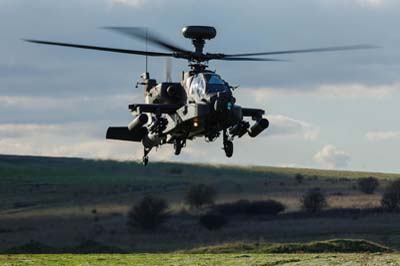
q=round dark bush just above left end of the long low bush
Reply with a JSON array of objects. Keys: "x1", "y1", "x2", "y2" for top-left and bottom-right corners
[{"x1": 185, "y1": 184, "x2": 217, "y2": 209}]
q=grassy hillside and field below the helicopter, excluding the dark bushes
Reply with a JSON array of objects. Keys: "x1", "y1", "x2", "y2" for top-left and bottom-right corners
[{"x1": 0, "y1": 155, "x2": 400, "y2": 265}]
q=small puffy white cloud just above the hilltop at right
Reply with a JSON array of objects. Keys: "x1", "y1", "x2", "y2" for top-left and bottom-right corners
[{"x1": 314, "y1": 145, "x2": 351, "y2": 169}]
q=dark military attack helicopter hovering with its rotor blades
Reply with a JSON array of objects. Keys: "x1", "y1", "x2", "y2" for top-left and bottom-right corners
[{"x1": 25, "y1": 26, "x2": 376, "y2": 165}]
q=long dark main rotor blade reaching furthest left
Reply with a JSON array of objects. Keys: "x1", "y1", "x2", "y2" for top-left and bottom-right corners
[{"x1": 24, "y1": 39, "x2": 174, "y2": 57}]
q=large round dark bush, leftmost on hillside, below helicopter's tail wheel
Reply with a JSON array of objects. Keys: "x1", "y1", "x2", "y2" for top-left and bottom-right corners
[{"x1": 128, "y1": 196, "x2": 169, "y2": 230}]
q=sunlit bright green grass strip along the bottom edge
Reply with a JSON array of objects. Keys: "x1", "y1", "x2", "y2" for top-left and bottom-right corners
[{"x1": 0, "y1": 254, "x2": 400, "y2": 266}]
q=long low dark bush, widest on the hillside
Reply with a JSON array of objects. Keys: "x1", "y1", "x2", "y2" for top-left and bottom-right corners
[{"x1": 215, "y1": 200, "x2": 285, "y2": 215}]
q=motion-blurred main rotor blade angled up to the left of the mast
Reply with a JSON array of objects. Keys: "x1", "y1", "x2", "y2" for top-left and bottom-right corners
[{"x1": 104, "y1": 27, "x2": 188, "y2": 52}]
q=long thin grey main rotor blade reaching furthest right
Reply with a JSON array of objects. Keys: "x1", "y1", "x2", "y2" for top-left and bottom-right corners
[{"x1": 224, "y1": 44, "x2": 379, "y2": 58}]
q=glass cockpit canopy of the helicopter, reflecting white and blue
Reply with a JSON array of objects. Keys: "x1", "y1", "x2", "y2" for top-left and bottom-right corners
[{"x1": 189, "y1": 73, "x2": 229, "y2": 98}]
